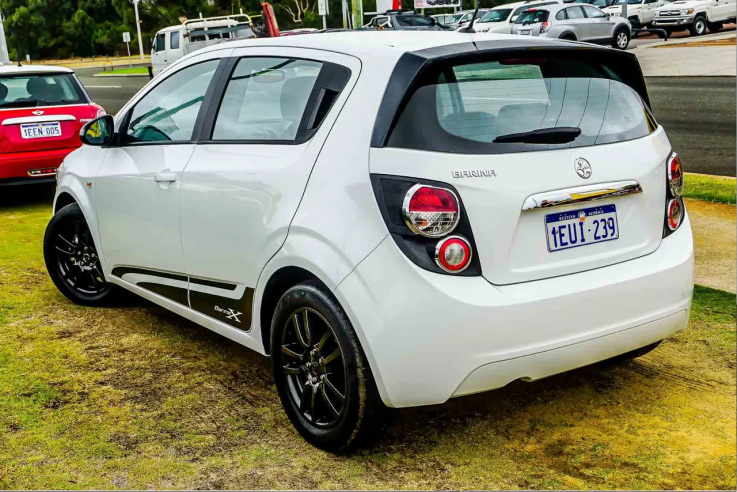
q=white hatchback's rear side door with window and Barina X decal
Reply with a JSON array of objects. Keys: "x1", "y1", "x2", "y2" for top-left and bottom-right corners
[{"x1": 181, "y1": 47, "x2": 360, "y2": 330}]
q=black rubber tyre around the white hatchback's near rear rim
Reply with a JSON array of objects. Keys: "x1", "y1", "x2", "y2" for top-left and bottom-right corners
[{"x1": 271, "y1": 283, "x2": 366, "y2": 452}]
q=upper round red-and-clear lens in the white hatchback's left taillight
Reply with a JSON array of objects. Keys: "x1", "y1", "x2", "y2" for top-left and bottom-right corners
[{"x1": 402, "y1": 185, "x2": 461, "y2": 237}]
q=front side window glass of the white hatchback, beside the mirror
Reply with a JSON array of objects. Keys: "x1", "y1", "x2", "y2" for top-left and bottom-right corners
[{"x1": 126, "y1": 60, "x2": 220, "y2": 142}]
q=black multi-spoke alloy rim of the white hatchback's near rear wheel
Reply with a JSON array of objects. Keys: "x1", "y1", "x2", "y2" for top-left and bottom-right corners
[{"x1": 281, "y1": 307, "x2": 348, "y2": 428}]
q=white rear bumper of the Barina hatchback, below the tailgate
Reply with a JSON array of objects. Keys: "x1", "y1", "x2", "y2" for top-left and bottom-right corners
[{"x1": 335, "y1": 217, "x2": 694, "y2": 407}]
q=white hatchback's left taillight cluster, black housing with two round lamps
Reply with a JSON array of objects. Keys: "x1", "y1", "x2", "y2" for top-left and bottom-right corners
[{"x1": 371, "y1": 174, "x2": 481, "y2": 277}]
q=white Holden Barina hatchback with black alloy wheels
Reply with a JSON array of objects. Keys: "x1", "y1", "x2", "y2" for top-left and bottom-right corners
[{"x1": 44, "y1": 32, "x2": 693, "y2": 451}]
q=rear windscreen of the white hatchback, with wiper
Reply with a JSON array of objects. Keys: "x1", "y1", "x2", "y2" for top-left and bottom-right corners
[{"x1": 386, "y1": 50, "x2": 657, "y2": 154}]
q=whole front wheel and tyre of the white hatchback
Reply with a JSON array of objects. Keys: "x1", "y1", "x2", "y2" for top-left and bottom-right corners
[{"x1": 43, "y1": 203, "x2": 120, "y2": 306}]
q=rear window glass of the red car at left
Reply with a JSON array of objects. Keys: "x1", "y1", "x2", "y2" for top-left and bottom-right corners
[{"x1": 0, "y1": 73, "x2": 87, "y2": 109}]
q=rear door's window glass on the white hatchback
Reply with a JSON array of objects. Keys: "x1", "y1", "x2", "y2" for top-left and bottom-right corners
[{"x1": 212, "y1": 58, "x2": 322, "y2": 141}]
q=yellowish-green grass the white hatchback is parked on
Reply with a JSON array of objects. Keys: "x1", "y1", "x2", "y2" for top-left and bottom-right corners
[{"x1": 0, "y1": 194, "x2": 737, "y2": 490}]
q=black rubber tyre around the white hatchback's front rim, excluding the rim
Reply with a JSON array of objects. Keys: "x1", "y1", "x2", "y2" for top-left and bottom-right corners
[{"x1": 43, "y1": 203, "x2": 115, "y2": 306}]
